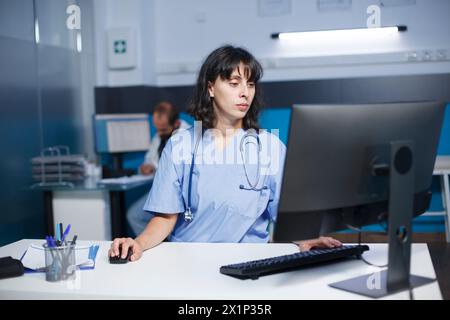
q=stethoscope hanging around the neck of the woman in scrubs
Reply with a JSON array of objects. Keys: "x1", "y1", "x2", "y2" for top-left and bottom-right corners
[{"x1": 184, "y1": 129, "x2": 268, "y2": 222}]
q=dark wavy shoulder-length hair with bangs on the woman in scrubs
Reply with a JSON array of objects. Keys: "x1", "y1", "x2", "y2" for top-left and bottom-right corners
[{"x1": 188, "y1": 45, "x2": 263, "y2": 130}]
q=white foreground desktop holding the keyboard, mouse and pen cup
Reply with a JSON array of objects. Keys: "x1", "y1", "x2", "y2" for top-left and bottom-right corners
[{"x1": 0, "y1": 240, "x2": 442, "y2": 300}]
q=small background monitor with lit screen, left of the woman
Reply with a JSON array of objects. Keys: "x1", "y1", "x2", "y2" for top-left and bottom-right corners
[{"x1": 94, "y1": 114, "x2": 151, "y2": 176}]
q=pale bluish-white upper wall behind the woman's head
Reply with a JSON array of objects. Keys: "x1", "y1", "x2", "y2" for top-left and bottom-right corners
[{"x1": 92, "y1": 0, "x2": 450, "y2": 86}]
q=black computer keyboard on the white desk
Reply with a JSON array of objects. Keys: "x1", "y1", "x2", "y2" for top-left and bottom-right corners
[{"x1": 220, "y1": 245, "x2": 369, "y2": 280}]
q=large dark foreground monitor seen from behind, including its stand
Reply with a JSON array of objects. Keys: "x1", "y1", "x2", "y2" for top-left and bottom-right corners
[{"x1": 273, "y1": 102, "x2": 445, "y2": 296}]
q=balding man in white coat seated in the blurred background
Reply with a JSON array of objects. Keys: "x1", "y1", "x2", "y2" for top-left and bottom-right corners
[{"x1": 127, "y1": 101, "x2": 190, "y2": 235}]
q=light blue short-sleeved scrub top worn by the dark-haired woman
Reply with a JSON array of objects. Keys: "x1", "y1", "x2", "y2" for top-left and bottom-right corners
[{"x1": 144, "y1": 127, "x2": 286, "y2": 243}]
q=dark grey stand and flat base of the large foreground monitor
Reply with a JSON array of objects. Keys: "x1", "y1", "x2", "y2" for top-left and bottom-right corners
[{"x1": 330, "y1": 141, "x2": 436, "y2": 298}]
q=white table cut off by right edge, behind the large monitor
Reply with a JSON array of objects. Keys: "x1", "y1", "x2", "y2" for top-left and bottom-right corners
[{"x1": 433, "y1": 156, "x2": 450, "y2": 243}]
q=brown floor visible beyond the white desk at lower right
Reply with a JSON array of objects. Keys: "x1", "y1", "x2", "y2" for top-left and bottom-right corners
[{"x1": 330, "y1": 233, "x2": 450, "y2": 300}]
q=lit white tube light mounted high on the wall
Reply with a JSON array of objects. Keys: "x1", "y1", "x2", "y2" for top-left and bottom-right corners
[{"x1": 271, "y1": 26, "x2": 408, "y2": 40}]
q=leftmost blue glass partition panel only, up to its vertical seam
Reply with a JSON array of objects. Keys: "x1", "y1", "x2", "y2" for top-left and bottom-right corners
[{"x1": 0, "y1": 0, "x2": 44, "y2": 246}]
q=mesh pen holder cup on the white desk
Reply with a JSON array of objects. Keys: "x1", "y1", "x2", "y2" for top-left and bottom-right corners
[{"x1": 44, "y1": 244, "x2": 77, "y2": 282}]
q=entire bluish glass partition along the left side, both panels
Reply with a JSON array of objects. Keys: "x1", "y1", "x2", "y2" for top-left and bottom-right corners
[{"x1": 0, "y1": 0, "x2": 89, "y2": 246}]
